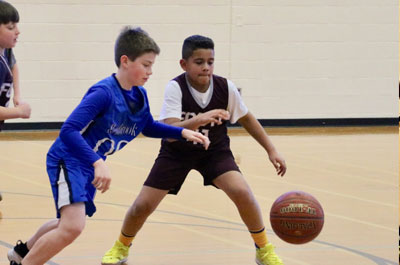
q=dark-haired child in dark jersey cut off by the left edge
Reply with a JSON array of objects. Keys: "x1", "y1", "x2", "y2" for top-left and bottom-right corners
[{"x1": 0, "y1": 1, "x2": 31, "y2": 130}]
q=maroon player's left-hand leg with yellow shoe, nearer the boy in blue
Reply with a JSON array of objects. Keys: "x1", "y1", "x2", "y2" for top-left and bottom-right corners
[{"x1": 101, "y1": 186, "x2": 168, "y2": 265}]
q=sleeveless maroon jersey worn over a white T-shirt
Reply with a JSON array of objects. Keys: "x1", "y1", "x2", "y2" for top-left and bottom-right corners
[{"x1": 162, "y1": 73, "x2": 229, "y2": 150}]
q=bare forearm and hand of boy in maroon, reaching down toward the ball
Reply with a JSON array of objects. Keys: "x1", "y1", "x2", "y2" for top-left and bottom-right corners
[{"x1": 238, "y1": 112, "x2": 287, "y2": 176}]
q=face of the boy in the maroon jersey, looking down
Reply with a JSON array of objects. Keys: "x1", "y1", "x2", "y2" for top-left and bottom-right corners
[{"x1": 180, "y1": 49, "x2": 214, "y2": 92}]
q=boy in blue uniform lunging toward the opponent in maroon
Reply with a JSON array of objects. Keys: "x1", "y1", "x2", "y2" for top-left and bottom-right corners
[{"x1": 8, "y1": 27, "x2": 209, "y2": 265}]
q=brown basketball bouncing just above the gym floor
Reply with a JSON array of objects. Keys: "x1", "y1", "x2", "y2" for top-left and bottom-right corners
[{"x1": 270, "y1": 191, "x2": 324, "y2": 244}]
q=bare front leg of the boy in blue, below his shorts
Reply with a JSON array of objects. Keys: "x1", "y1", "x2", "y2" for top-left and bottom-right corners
[{"x1": 21, "y1": 202, "x2": 86, "y2": 265}]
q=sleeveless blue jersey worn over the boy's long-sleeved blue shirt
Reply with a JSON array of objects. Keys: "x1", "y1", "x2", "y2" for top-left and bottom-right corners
[{"x1": 49, "y1": 73, "x2": 151, "y2": 159}]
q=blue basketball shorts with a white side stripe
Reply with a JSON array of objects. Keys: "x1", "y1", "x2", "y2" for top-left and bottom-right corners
[{"x1": 46, "y1": 154, "x2": 96, "y2": 218}]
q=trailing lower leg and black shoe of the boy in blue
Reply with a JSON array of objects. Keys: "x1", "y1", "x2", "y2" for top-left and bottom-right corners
[{"x1": 7, "y1": 219, "x2": 59, "y2": 263}]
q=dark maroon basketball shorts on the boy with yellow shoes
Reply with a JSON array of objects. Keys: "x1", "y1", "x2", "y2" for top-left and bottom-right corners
[{"x1": 144, "y1": 150, "x2": 240, "y2": 194}]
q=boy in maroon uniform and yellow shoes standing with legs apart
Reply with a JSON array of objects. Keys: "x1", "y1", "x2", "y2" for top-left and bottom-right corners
[{"x1": 102, "y1": 35, "x2": 286, "y2": 265}]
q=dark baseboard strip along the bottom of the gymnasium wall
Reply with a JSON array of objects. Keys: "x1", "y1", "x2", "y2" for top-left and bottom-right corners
[{"x1": 2, "y1": 117, "x2": 399, "y2": 131}]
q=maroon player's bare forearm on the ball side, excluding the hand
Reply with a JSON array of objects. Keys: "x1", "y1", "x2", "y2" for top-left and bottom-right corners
[{"x1": 238, "y1": 112, "x2": 276, "y2": 154}]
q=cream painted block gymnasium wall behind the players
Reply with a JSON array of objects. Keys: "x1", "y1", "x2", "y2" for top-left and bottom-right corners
[{"x1": 9, "y1": 0, "x2": 399, "y2": 122}]
